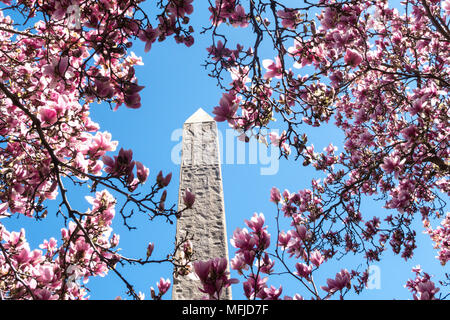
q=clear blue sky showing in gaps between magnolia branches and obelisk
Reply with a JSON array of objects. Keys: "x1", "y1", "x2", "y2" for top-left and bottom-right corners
[{"x1": 2, "y1": 1, "x2": 445, "y2": 299}]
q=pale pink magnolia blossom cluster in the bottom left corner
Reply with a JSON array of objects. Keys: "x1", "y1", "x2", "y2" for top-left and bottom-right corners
[{"x1": 0, "y1": 190, "x2": 120, "y2": 300}]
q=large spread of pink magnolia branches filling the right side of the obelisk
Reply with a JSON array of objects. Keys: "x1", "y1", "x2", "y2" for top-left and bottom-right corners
[{"x1": 206, "y1": 0, "x2": 450, "y2": 295}]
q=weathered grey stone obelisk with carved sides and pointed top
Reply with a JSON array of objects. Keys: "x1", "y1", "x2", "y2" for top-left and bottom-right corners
[{"x1": 172, "y1": 108, "x2": 231, "y2": 300}]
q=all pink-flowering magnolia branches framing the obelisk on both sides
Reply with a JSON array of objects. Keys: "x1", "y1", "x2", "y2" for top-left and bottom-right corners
[{"x1": 0, "y1": 0, "x2": 450, "y2": 299}]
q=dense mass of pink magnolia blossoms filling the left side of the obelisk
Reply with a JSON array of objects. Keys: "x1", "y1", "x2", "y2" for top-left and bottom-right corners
[{"x1": 0, "y1": 0, "x2": 199, "y2": 299}]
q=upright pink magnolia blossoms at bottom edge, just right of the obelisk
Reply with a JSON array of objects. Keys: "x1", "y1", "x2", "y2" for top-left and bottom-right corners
[{"x1": 230, "y1": 209, "x2": 367, "y2": 300}]
